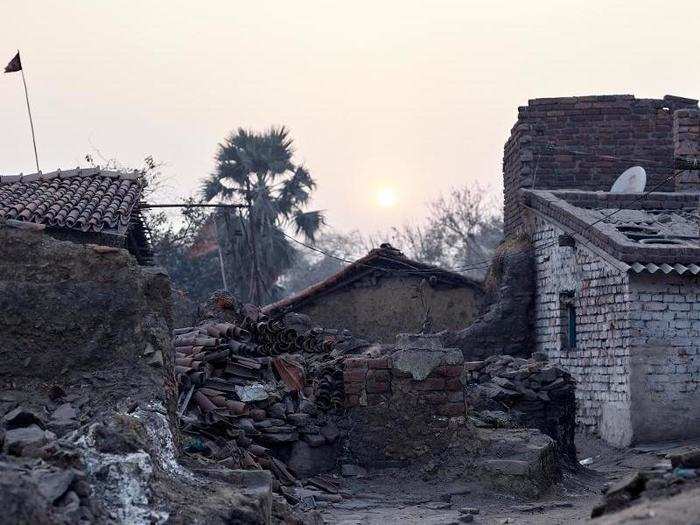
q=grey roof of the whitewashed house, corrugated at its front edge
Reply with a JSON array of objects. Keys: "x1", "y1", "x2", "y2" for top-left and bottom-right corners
[{"x1": 523, "y1": 190, "x2": 700, "y2": 274}]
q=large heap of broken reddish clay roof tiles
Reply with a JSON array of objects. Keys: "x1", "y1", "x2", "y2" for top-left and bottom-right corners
[{"x1": 173, "y1": 315, "x2": 344, "y2": 485}]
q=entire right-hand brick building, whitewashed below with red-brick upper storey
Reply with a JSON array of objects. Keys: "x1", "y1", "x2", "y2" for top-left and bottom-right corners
[{"x1": 504, "y1": 95, "x2": 700, "y2": 445}]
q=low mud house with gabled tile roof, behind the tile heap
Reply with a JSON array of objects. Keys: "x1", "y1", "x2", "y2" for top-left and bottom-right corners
[{"x1": 265, "y1": 245, "x2": 483, "y2": 343}]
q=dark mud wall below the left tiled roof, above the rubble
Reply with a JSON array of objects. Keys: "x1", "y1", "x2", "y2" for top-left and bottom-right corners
[{"x1": 0, "y1": 223, "x2": 176, "y2": 422}]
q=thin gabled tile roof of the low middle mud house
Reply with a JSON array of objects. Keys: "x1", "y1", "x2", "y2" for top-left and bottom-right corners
[{"x1": 263, "y1": 244, "x2": 483, "y2": 314}]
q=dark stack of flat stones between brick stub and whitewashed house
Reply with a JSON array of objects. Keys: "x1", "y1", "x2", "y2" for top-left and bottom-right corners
[{"x1": 465, "y1": 355, "x2": 576, "y2": 462}]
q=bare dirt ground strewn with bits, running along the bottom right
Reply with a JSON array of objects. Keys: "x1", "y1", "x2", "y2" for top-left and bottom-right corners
[{"x1": 317, "y1": 435, "x2": 700, "y2": 525}]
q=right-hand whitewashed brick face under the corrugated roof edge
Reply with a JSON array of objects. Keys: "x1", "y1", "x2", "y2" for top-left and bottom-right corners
[{"x1": 630, "y1": 274, "x2": 700, "y2": 441}]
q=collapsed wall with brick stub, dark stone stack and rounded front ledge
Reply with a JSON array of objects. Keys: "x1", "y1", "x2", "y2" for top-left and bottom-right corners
[{"x1": 341, "y1": 334, "x2": 576, "y2": 496}]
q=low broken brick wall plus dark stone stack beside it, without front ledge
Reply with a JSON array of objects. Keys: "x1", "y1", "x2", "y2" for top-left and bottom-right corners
[{"x1": 344, "y1": 342, "x2": 576, "y2": 464}]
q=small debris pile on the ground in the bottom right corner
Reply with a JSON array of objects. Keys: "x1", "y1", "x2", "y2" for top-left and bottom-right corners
[{"x1": 591, "y1": 448, "x2": 700, "y2": 518}]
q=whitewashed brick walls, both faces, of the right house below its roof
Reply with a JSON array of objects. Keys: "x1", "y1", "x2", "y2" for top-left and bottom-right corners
[{"x1": 533, "y1": 217, "x2": 700, "y2": 446}]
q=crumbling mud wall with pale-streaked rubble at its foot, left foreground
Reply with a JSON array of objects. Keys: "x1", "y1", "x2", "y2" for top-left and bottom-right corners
[{"x1": 0, "y1": 222, "x2": 284, "y2": 525}]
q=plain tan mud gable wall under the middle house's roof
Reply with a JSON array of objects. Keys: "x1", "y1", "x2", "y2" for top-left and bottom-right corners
[{"x1": 294, "y1": 277, "x2": 482, "y2": 343}]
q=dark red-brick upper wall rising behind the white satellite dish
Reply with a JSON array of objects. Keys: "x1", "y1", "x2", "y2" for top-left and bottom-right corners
[{"x1": 503, "y1": 95, "x2": 697, "y2": 235}]
